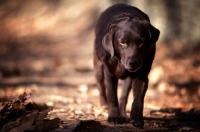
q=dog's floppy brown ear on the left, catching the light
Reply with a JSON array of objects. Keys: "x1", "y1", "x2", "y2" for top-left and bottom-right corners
[{"x1": 102, "y1": 28, "x2": 114, "y2": 57}]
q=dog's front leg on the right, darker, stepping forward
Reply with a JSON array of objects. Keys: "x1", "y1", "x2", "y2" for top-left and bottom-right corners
[{"x1": 131, "y1": 77, "x2": 148, "y2": 128}]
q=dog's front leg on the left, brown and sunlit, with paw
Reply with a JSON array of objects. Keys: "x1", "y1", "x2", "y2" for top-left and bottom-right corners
[{"x1": 104, "y1": 68, "x2": 121, "y2": 124}]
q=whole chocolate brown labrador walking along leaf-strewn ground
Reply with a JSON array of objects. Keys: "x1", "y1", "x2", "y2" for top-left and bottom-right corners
[{"x1": 94, "y1": 4, "x2": 160, "y2": 127}]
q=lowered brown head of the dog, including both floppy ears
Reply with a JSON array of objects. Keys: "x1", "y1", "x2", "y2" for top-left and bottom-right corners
[{"x1": 102, "y1": 19, "x2": 160, "y2": 72}]
